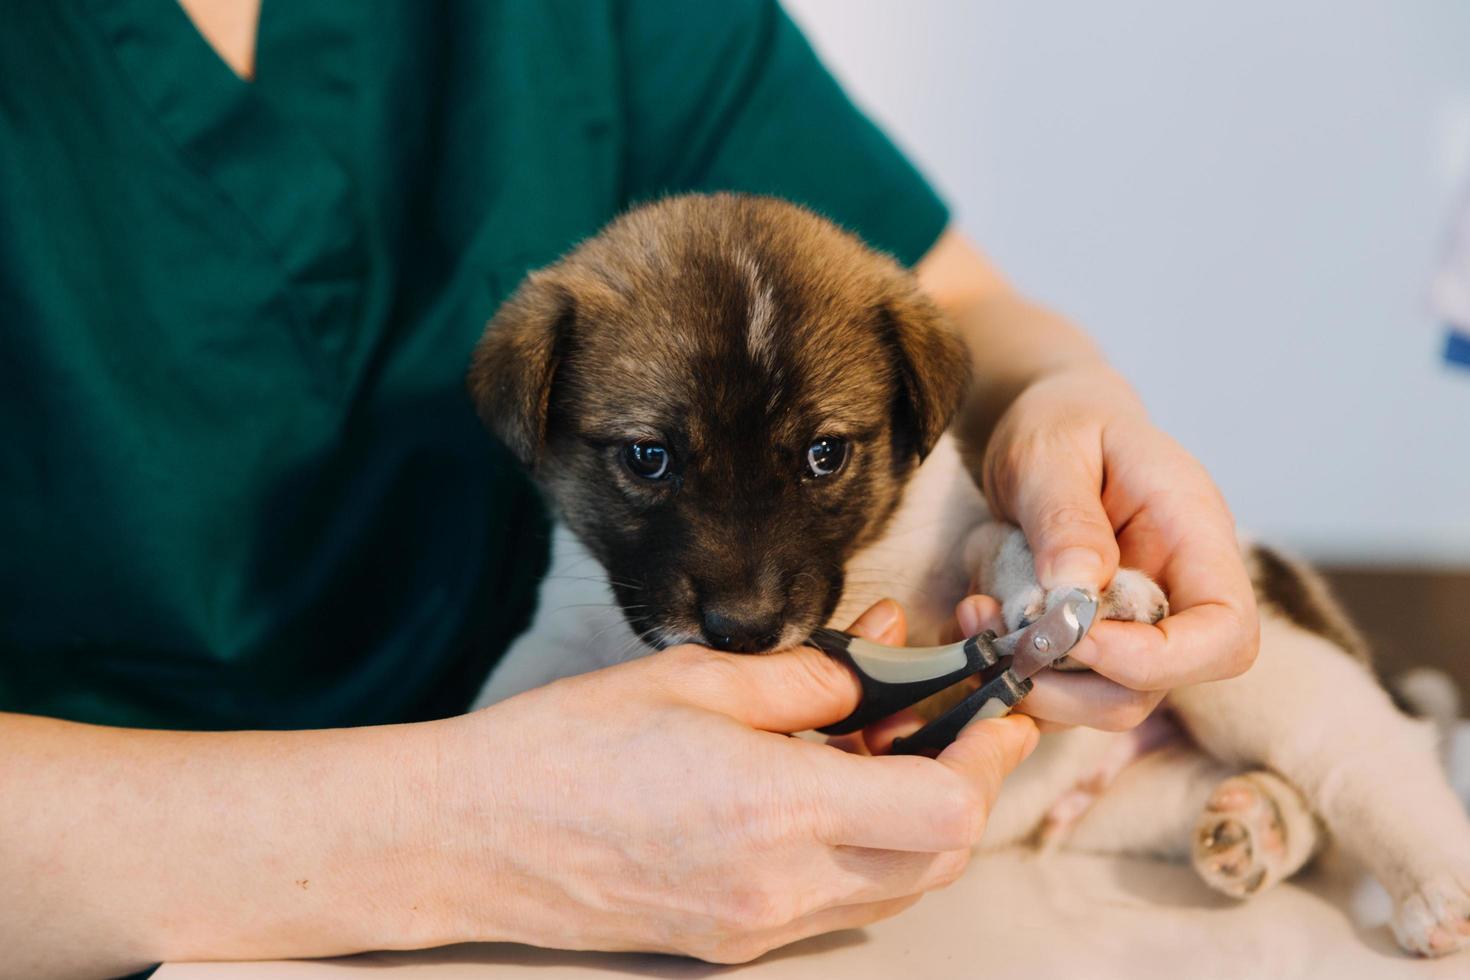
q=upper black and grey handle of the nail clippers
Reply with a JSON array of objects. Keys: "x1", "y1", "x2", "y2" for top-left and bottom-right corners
[{"x1": 807, "y1": 629, "x2": 1000, "y2": 735}]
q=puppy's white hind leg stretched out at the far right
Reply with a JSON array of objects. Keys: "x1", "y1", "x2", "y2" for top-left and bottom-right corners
[{"x1": 1169, "y1": 607, "x2": 1470, "y2": 955}]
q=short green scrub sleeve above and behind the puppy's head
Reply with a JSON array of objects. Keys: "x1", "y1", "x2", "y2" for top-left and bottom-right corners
[{"x1": 619, "y1": 0, "x2": 948, "y2": 266}]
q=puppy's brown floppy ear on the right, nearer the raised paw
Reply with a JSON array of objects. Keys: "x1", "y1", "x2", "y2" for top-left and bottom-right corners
[{"x1": 878, "y1": 285, "x2": 970, "y2": 460}]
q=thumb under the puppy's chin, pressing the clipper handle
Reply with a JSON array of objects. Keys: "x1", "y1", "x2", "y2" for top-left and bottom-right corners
[{"x1": 670, "y1": 599, "x2": 906, "y2": 733}]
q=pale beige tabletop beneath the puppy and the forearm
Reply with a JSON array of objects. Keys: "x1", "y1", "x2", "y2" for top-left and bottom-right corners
[{"x1": 157, "y1": 727, "x2": 1470, "y2": 980}]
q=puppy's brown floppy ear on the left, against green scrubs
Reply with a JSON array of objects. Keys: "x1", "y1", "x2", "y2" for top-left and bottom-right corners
[{"x1": 467, "y1": 270, "x2": 576, "y2": 469}]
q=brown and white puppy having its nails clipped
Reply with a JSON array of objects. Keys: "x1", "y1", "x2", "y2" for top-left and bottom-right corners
[{"x1": 469, "y1": 194, "x2": 1470, "y2": 955}]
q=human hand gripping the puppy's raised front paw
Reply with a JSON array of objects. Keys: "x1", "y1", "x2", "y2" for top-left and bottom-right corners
[{"x1": 957, "y1": 361, "x2": 1258, "y2": 730}]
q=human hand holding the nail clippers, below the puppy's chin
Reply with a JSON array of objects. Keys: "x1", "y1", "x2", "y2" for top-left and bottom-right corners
[{"x1": 438, "y1": 601, "x2": 1036, "y2": 962}]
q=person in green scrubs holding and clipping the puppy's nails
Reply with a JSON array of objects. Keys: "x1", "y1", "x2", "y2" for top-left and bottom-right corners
[{"x1": 0, "y1": 0, "x2": 1255, "y2": 977}]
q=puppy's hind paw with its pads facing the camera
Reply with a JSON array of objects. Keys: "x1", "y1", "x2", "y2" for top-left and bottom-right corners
[{"x1": 1194, "y1": 773, "x2": 1316, "y2": 898}]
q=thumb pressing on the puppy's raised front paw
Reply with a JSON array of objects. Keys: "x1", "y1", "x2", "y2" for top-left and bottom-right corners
[{"x1": 1011, "y1": 455, "x2": 1119, "y2": 589}]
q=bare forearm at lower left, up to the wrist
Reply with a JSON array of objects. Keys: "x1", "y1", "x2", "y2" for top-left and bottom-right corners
[{"x1": 0, "y1": 714, "x2": 450, "y2": 977}]
